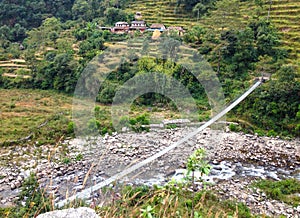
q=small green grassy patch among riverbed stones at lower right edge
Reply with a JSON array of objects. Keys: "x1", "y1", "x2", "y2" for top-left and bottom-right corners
[{"x1": 253, "y1": 179, "x2": 300, "y2": 207}]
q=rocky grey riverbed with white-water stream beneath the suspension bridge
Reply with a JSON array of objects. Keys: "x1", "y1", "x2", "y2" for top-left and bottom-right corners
[{"x1": 0, "y1": 127, "x2": 300, "y2": 217}]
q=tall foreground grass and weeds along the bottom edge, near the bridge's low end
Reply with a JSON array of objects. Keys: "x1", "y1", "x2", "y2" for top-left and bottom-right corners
[{"x1": 0, "y1": 174, "x2": 257, "y2": 218}]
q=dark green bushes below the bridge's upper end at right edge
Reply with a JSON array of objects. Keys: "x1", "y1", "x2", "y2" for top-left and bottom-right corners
[{"x1": 237, "y1": 65, "x2": 300, "y2": 136}]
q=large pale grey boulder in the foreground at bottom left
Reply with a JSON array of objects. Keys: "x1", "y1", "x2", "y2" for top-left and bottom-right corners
[{"x1": 37, "y1": 207, "x2": 99, "y2": 218}]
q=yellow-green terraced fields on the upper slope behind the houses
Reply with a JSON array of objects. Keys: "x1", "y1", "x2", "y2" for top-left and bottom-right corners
[{"x1": 126, "y1": 0, "x2": 300, "y2": 73}]
